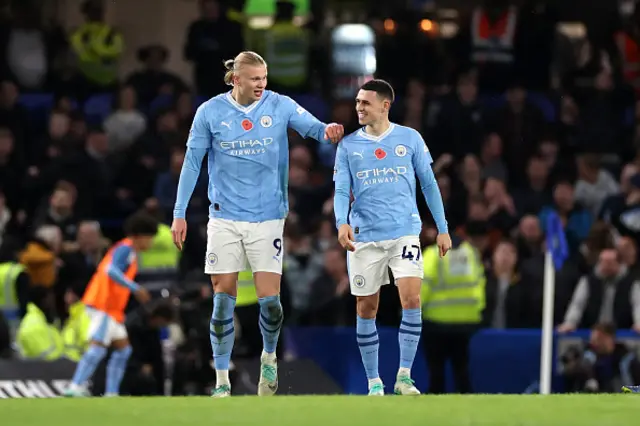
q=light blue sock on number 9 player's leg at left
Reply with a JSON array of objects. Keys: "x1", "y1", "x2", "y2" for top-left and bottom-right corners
[{"x1": 209, "y1": 293, "x2": 236, "y2": 370}]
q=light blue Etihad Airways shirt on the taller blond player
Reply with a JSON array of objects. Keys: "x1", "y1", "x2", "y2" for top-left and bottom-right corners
[{"x1": 174, "y1": 90, "x2": 329, "y2": 222}]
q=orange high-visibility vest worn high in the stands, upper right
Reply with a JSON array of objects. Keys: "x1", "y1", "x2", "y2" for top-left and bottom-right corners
[{"x1": 471, "y1": 6, "x2": 518, "y2": 64}]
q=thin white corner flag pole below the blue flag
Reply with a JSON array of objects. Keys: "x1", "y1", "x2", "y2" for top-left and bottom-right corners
[{"x1": 540, "y1": 247, "x2": 555, "y2": 395}]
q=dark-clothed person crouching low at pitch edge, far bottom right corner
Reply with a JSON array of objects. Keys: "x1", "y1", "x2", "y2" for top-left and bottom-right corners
[{"x1": 562, "y1": 323, "x2": 640, "y2": 393}]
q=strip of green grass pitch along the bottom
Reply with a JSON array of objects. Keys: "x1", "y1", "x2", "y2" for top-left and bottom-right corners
[{"x1": 0, "y1": 394, "x2": 640, "y2": 426}]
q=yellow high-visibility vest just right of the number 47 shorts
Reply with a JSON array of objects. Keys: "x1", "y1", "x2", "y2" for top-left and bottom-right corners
[{"x1": 421, "y1": 241, "x2": 486, "y2": 324}]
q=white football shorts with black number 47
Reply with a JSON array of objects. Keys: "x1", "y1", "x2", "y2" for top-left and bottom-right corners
[{"x1": 347, "y1": 235, "x2": 424, "y2": 296}]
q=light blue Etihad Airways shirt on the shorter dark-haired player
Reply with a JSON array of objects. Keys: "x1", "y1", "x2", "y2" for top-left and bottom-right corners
[{"x1": 333, "y1": 123, "x2": 448, "y2": 242}]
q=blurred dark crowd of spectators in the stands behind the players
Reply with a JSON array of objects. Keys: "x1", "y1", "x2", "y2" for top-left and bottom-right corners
[{"x1": 5, "y1": 0, "x2": 640, "y2": 393}]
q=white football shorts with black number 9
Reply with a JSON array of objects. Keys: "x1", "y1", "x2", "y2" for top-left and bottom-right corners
[{"x1": 204, "y1": 218, "x2": 284, "y2": 275}]
